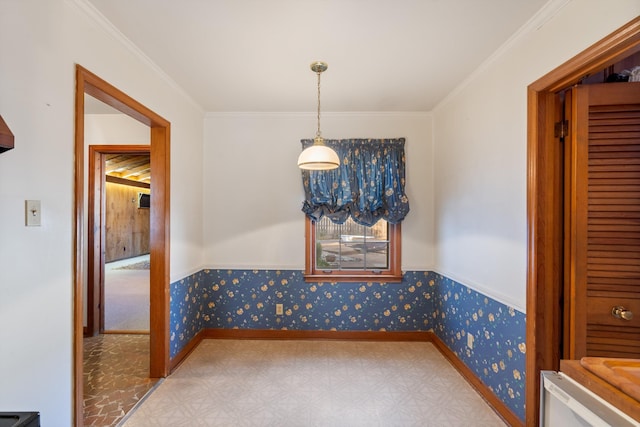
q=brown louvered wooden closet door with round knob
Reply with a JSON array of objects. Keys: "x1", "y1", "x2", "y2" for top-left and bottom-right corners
[{"x1": 568, "y1": 83, "x2": 640, "y2": 358}]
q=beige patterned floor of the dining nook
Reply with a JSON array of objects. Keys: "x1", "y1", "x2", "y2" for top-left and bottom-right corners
[{"x1": 121, "y1": 340, "x2": 505, "y2": 427}]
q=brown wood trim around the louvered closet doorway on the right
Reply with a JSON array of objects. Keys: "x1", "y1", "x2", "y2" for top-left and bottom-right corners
[{"x1": 526, "y1": 17, "x2": 640, "y2": 427}]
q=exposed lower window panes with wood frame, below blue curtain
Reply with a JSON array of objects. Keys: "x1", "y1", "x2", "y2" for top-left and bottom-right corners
[{"x1": 305, "y1": 217, "x2": 402, "y2": 282}]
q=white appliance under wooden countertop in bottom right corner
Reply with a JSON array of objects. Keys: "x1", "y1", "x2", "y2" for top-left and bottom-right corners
[{"x1": 540, "y1": 371, "x2": 640, "y2": 427}]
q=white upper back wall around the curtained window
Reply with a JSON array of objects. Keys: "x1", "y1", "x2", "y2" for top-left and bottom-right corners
[{"x1": 203, "y1": 113, "x2": 434, "y2": 270}]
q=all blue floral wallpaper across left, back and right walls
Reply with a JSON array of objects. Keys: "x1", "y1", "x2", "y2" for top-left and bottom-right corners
[{"x1": 170, "y1": 269, "x2": 526, "y2": 420}]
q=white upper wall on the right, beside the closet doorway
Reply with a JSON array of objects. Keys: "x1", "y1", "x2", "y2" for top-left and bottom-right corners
[{"x1": 434, "y1": 0, "x2": 640, "y2": 311}]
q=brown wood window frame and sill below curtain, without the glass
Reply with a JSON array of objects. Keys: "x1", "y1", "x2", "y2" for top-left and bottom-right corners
[{"x1": 304, "y1": 215, "x2": 402, "y2": 282}]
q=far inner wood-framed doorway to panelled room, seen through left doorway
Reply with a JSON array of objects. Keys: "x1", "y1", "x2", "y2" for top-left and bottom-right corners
[{"x1": 85, "y1": 145, "x2": 151, "y2": 336}]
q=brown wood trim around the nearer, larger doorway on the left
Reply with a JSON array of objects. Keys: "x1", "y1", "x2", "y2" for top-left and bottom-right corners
[{"x1": 73, "y1": 65, "x2": 171, "y2": 426}]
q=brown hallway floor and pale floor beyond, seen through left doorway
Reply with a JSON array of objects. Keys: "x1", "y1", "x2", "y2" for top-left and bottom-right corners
[{"x1": 83, "y1": 254, "x2": 157, "y2": 426}]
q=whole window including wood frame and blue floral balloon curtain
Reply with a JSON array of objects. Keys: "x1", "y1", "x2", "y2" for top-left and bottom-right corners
[{"x1": 301, "y1": 138, "x2": 409, "y2": 282}]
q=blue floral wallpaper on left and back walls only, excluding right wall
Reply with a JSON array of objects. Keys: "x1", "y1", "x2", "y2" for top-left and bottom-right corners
[{"x1": 171, "y1": 270, "x2": 434, "y2": 357}]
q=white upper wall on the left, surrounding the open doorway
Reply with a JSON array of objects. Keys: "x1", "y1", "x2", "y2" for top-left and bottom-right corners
[{"x1": 0, "y1": 0, "x2": 203, "y2": 426}]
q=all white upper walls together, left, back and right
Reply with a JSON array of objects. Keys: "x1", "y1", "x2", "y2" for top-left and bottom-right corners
[{"x1": 0, "y1": 0, "x2": 640, "y2": 426}]
